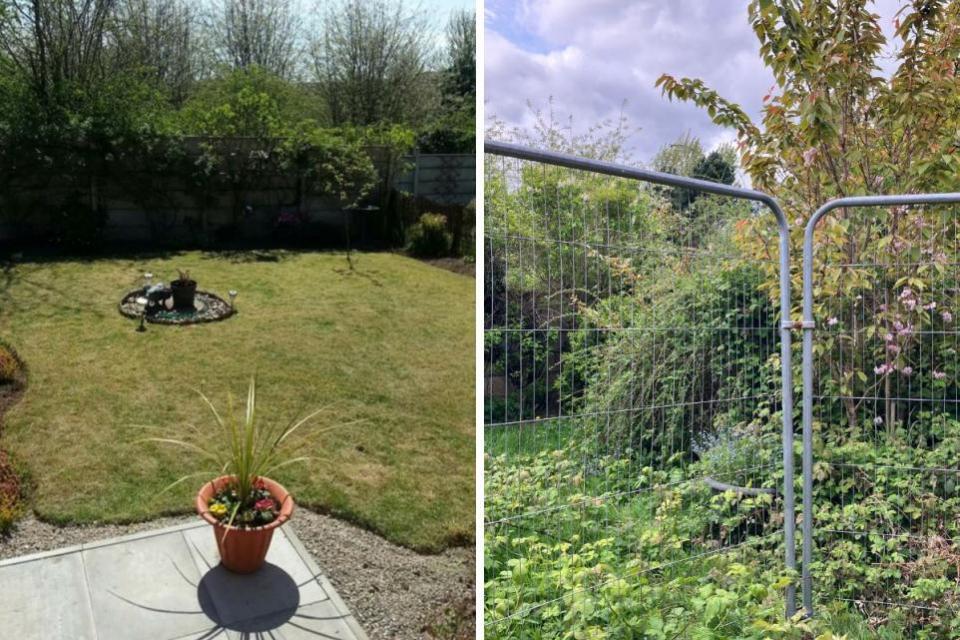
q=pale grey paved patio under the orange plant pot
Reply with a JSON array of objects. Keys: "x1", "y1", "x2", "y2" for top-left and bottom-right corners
[{"x1": 0, "y1": 522, "x2": 366, "y2": 640}]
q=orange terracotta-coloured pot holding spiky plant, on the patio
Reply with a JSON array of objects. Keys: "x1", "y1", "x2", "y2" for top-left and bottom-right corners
[{"x1": 197, "y1": 476, "x2": 293, "y2": 573}]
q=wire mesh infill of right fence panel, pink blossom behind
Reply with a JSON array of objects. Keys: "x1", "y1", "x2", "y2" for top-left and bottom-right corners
[{"x1": 808, "y1": 199, "x2": 960, "y2": 638}]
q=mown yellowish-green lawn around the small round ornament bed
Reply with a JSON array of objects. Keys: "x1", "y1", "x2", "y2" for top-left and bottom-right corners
[{"x1": 0, "y1": 252, "x2": 474, "y2": 550}]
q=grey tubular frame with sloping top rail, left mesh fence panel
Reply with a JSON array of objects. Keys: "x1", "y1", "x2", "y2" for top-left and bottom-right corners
[{"x1": 484, "y1": 140, "x2": 806, "y2": 617}]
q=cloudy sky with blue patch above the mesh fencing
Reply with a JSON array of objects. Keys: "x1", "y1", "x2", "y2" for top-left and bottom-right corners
[{"x1": 484, "y1": 0, "x2": 904, "y2": 162}]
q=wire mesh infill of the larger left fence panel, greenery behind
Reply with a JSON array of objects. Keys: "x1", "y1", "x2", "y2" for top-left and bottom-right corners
[{"x1": 484, "y1": 146, "x2": 789, "y2": 638}]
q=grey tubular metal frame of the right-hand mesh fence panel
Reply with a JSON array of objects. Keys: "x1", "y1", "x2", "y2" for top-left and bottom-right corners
[{"x1": 800, "y1": 193, "x2": 960, "y2": 617}]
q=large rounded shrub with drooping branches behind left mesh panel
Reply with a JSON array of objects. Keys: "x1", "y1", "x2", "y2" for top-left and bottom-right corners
[{"x1": 564, "y1": 258, "x2": 779, "y2": 460}]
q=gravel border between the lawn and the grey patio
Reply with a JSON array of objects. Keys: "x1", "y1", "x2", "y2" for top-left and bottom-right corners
[{"x1": 0, "y1": 508, "x2": 475, "y2": 640}]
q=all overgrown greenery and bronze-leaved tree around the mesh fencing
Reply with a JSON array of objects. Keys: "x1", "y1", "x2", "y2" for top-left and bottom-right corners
[{"x1": 485, "y1": 0, "x2": 960, "y2": 639}]
